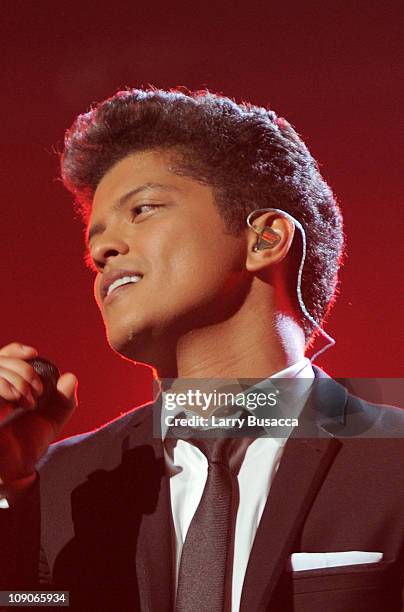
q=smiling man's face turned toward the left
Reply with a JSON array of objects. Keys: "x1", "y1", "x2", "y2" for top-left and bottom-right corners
[{"x1": 88, "y1": 151, "x2": 247, "y2": 367}]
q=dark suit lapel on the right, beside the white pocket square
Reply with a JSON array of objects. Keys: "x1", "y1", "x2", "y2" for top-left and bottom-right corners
[{"x1": 240, "y1": 368, "x2": 346, "y2": 612}]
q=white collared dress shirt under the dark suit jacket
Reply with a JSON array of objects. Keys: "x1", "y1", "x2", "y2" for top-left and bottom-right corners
[{"x1": 164, "y1": 358, "x2": 314, "y2": 612}]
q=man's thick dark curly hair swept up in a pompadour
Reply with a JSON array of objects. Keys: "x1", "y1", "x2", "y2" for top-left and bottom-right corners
[{"x1": 61, "y1": 87, "x2": 344, "y2": 342}]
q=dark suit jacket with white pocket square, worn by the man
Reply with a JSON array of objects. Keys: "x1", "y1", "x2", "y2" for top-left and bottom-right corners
[{"x1": 0, "y1": 368, "x2": 404, "y2": 612}]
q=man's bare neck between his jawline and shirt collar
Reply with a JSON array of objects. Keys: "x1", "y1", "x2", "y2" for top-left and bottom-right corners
[{"x1": 133, "y1": 272, "x2": 305, "y2": 379}]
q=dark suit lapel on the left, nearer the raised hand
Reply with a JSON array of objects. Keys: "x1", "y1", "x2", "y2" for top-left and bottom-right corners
[{"x1": 136, "y1": 404, "x2": 173, "y2": 612}]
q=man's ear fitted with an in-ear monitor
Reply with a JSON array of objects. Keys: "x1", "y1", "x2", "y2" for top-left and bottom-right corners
[{"x1": 246, "y1": 212, "x2": 295, "y2": 272}]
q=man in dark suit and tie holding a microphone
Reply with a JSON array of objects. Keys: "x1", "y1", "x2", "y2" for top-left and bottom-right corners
[{"x1": 0, "y1": 90, "x2": 404, "y2": 612}]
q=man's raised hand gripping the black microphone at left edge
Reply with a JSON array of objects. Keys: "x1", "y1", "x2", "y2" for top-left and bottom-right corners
[{"x1": 0, "y1": 342, "x2": 77, "y2": 496}]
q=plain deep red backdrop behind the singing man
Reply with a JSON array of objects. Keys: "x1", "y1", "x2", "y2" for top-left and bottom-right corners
[{"x1": 0, "y1": 0, "x2": 404, "y2": 434}]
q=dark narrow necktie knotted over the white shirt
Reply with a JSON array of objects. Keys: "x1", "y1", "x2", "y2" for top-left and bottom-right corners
[{"x1": 171, "y1": 427, "x2": 234, "y2": 612}]
